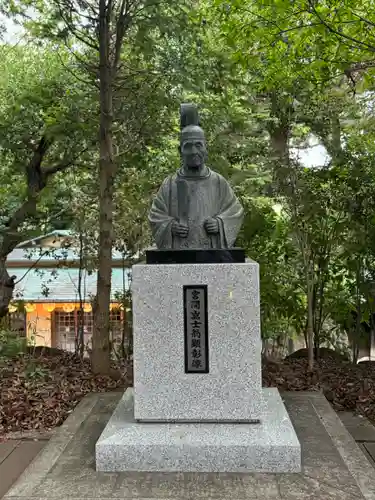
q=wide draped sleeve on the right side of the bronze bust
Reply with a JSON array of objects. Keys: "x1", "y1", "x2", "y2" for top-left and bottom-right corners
[{"x1": 216, "y1": 176, "x2": 244, "y2": 248}]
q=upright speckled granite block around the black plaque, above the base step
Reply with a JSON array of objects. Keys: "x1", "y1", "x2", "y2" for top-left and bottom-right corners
[{"x1": 132, "y1": 261, "x2": 262, "y2": 421}]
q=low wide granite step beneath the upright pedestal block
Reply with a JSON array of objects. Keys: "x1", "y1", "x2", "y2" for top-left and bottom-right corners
[{"x1": 96, "y1": 389, "x2": 301, "y2": 472}]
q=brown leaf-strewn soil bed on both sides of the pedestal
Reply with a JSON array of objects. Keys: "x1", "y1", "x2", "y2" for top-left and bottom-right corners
[{"x1": 0, "y1": 351, "x2": 375, "y2": 438}]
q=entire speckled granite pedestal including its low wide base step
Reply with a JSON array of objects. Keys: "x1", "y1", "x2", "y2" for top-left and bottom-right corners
[{"x1": 96, "y1": 254, "x2": 301, "y2": 472}]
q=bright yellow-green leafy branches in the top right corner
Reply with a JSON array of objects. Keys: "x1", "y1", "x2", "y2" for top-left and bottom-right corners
[{"x1": 208, "y1": 0, "x2": 375, "y2": 89}]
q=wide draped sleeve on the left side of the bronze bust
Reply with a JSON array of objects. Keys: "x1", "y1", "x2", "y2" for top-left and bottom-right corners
[{"x1": 148, "y1": 177, "x2": 174, "y2": 249}]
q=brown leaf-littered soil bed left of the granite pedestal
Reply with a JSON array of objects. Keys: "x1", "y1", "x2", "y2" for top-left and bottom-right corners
[{"x1": 0, "y1": 350, "x2": 132, "y2": 438}]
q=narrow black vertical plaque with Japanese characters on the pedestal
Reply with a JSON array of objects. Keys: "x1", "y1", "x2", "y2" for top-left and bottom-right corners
[{"x1": 183, "y1": 285, "x2": 209, "y2": 373}]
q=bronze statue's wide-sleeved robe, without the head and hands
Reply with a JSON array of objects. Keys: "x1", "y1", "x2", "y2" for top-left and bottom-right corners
[{"x1": 149, "y1": 169, "x2": 243, "y2": 249}]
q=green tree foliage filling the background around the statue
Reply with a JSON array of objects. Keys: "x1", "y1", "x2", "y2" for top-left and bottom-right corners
[{"x1": 0, "y1": 0, "x2": 375, "y2": 364}]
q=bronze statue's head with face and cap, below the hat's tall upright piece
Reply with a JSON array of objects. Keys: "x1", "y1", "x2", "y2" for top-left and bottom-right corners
[{"x1": 180, "y1": 125, "x2": 207, "y2": 172}]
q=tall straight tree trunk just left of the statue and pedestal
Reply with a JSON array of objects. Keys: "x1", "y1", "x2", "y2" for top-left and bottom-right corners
[{"x1": 91, "y1": 0, "x2": 116, "y2": 375}]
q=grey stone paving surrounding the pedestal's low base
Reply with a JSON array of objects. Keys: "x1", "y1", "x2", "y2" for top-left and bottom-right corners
[{"x1": 4, "y1": 393, "x2": 375, "y2": 500}]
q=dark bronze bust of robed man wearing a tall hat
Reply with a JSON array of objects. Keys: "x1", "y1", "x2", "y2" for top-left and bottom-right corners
[{"x1": 149, "y1": 105, "x2": 243, "y2": 249}]
